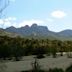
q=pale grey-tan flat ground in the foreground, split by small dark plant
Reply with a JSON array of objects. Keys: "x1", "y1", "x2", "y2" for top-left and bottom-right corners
[{"x1": 0, "y1": 56, "x2": 72, "y2": 72}]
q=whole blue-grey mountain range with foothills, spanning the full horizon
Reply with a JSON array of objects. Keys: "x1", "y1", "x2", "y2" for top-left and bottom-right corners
[{"x1": 0, "y1": 23, "x2": 72, "y2": 40}]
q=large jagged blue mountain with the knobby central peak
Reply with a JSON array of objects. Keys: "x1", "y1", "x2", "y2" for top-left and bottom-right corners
[{"x1": 4, "y1": 23, "x2": 56, "y2": 39}]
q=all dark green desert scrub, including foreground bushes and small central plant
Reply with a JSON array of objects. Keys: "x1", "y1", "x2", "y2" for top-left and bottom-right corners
[{"x1": 0, "y1": 36, "x2": 72, "y2": 72}]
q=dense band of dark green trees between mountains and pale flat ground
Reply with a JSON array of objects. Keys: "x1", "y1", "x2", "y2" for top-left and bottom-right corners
[{"x1": 0, "y1": 36, "x2": 72, "y2": 60}]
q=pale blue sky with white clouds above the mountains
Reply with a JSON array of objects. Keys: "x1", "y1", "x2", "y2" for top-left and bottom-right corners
[{"x1": 0, "y1": 0, "x2": 72, "y2": 32}]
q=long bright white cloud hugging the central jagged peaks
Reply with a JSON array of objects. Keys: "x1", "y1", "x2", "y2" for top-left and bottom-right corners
[{"x1": 19, "y1": 19, "x2": 44, "y2": 27}]
